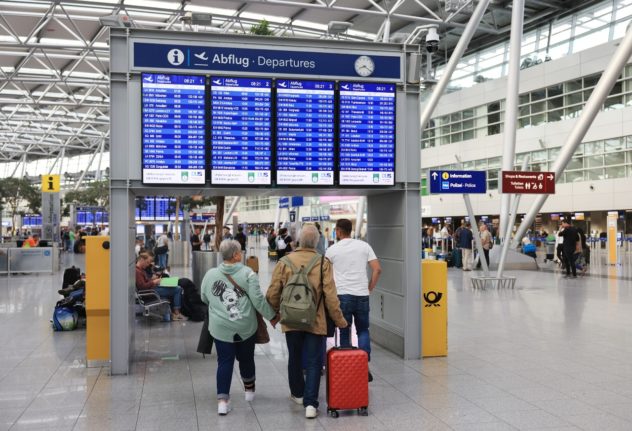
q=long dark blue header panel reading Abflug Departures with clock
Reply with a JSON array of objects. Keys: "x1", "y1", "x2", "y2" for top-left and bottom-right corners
[{"x1": 134, "y1": 42, "x2": 401, "y2": 81}]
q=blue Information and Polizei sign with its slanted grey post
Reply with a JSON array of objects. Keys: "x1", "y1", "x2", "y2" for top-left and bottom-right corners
[{"x1": 428, "y1": 170, "x2": 489, "y2": 277}]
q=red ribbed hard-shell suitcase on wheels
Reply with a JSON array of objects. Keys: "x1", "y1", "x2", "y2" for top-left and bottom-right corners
[{"x1": 327, "y1": 337, "x2": 369, "y2": 418}]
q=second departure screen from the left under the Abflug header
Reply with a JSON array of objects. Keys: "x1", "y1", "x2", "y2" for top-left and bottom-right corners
[{"x1": 211, "y1": 77, "x2": 272, "y2": 185}]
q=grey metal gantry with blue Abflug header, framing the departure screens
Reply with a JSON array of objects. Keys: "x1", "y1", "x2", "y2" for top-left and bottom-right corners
[{"x1": 110, "y1": 28, "x2": 421, "y2": 374}]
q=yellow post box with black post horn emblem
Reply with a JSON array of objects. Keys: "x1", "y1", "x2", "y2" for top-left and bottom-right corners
[{"x1": 421, "y1": 260, "x2": 448, "y2": 358}]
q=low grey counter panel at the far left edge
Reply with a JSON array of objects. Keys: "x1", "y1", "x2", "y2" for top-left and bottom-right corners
[{"x1": 0, "y1": 247, "x2": 58, "y2": 273}]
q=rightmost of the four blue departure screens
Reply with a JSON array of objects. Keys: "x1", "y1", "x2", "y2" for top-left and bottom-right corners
[{"x1": 339, "y1": 82, "x2": 395, "y2": 186}]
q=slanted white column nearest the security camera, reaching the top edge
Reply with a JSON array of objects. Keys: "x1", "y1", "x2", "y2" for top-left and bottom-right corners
[{"x1": 421, "y1": 0, "x2": 490, "y2": 135}]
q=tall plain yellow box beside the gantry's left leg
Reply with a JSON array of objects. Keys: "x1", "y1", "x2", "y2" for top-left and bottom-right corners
[{"x1": 85, "y1": 236, "x2": 110, "y2": 367}]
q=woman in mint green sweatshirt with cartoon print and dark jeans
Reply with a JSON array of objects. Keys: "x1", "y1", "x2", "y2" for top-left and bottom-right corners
[{"x1": 202, "y1": 239, "x2": 277, "y2": 415}]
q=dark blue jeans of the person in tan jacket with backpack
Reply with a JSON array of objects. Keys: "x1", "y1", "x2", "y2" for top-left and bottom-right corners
[{"x1": 285, "y1": 331, "x2": 325, "y2": 408}]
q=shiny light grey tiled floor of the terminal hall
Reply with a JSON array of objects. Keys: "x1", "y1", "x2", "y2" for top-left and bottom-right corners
[{"x1": 0, "y1": 248, "x2": 632, "y2": 431}]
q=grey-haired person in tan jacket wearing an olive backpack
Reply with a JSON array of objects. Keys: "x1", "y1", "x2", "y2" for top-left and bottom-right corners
[{"x1": 266, "y1": 226, "x2": 347, "y2": 419}]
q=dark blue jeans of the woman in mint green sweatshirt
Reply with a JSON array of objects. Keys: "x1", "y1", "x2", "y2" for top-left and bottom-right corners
[{"x1": 215, "y1": 334, "x2": 255, "y2": 400}]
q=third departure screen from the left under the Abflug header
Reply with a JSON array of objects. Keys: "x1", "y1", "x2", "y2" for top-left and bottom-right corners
[{"x1": 276, "y1": 80, "x2": 334, "y2": 186}]
